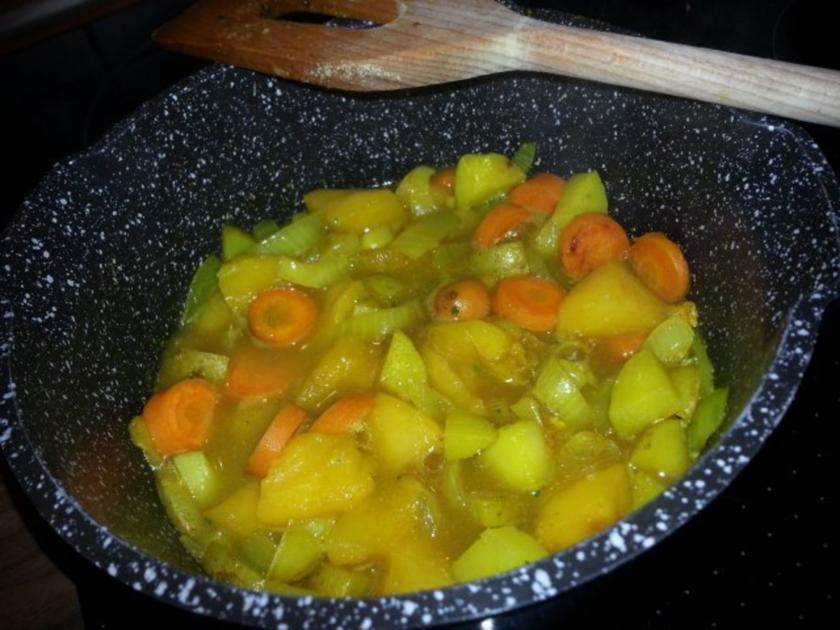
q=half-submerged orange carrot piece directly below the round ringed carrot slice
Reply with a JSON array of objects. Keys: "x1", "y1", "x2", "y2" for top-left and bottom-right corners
[{"x1": 225, "y1": 345, "x2": 299, "y2": 399}]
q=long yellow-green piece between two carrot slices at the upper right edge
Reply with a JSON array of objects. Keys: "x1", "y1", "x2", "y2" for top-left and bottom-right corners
[{"x1": 534, "y1": 171, "x2": 607, "y2": 256}]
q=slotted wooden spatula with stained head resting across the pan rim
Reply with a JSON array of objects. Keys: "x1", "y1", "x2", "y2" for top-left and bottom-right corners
[{"x1": 154, "y1": 0, "x2": 840, "y2": 127}]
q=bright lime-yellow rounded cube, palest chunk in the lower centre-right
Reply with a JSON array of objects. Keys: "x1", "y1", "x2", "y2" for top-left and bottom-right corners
[{"x1": 478, "y1": 420, "x2": 552, "y2": 492}]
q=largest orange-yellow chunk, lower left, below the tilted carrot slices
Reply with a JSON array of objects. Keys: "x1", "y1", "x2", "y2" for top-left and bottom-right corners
[{"x1": 257, "y1": 433, "x2": 374, "y2": 527}]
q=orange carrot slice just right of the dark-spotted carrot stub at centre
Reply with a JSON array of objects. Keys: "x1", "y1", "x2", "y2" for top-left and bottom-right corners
[{"x1": 493, "y1": 276, "x2": 566, "y2": 332}]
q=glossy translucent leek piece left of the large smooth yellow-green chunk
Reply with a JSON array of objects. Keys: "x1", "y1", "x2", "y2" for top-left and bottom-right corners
[{"x1": 533, "y1": 357, "x2": 594, "y2": 428}]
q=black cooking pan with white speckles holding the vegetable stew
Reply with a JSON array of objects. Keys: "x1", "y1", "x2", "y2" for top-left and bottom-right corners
[{"x1": 0, "y1": 9, "x2": 840, "y2": 628}]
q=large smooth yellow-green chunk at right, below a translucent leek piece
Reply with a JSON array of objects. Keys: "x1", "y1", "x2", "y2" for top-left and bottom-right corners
[{"x1": 609, "y1": 349, "x2": 680, "y2": 438}]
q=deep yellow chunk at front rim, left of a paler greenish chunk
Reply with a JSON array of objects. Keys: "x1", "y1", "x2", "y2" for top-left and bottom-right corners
[{"x1": 382, "y1": 539, "x2": 453, "y2": 595}]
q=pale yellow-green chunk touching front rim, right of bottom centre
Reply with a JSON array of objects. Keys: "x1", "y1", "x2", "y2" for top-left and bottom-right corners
[{"x1": 452, "y1": 526, "x2": 548, "y2": 582}]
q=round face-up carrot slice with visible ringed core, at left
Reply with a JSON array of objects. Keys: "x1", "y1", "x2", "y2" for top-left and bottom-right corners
[{"x1": 248, "y1": 289, "x2": 318, "y2": 346}]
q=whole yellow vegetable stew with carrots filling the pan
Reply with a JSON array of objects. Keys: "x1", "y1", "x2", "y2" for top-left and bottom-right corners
[{"x1": 131, "y1": 145, "x2": 727, "y2": 596}]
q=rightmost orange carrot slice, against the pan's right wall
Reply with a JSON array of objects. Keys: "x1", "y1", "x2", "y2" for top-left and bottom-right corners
[{"x1": 630, "y1": 232, "x2": 689, "y2": 302}]
